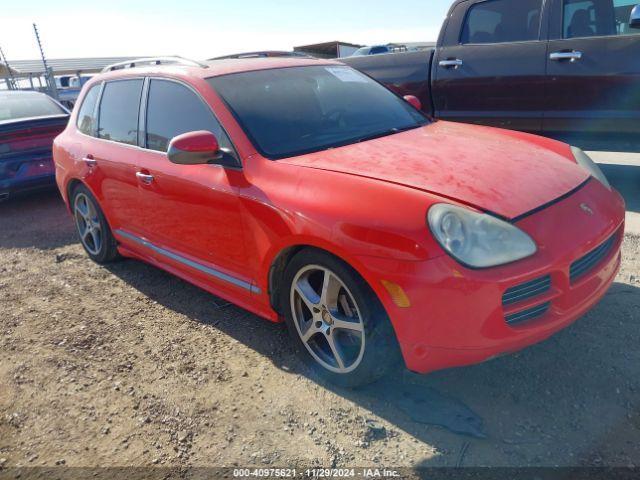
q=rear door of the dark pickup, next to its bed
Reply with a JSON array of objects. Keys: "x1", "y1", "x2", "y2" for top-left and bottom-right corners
[{"x1": 433, "y1": 0, "x2": 547, "y2": 132}]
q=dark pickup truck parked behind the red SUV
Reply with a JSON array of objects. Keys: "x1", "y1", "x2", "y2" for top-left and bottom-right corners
[{"x1": 341, "y1": 0, "x2": 640, "y2": 151}]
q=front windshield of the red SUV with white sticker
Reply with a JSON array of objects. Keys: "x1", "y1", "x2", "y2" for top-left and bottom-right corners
[{"x1": 208, "y1": 65, "x2": 428, "y2": 159}]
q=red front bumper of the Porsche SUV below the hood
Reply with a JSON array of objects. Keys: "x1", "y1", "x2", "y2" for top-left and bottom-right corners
[{"x1": 366, "y1": 180, "x2": 624, "y2": 373}]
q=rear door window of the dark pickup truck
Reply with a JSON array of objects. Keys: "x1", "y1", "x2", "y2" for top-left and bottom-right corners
[{"x1": 461, "y1": 0, "x2": 542, "y2": 43}]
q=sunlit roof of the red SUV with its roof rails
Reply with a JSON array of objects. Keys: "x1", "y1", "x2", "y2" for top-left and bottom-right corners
[{"x1": 94, "y1": 57, "x2": 344, "y2": 80}]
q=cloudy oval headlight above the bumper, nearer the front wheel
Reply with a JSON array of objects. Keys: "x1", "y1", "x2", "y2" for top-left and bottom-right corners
[{"x1": 427, "y1": 203, "x2": 537, "y2": 268}]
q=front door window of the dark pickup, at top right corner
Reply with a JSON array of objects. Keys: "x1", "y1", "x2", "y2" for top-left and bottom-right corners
[{"x1": 562, "y1": 0, "x2": 640, "y2": 38}]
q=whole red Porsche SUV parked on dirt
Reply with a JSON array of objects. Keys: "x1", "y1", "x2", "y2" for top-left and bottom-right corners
[{"x1": 54, "y1": 58, "x2": 624, "y2": 386}]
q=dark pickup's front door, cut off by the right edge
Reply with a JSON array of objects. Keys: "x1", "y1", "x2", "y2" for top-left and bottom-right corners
[{"x1": 544, "y1": 0, "x2": 640, "y2": 148}]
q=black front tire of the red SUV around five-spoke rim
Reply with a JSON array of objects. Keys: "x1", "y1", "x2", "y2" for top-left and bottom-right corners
[{"x1": 279, "y1": 248, "x2": 401, "y2": 388}]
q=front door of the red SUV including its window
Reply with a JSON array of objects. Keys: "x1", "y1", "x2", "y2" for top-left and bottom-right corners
[{"x1": 132, "y1": 79, "x2": 251, "y2": 291}]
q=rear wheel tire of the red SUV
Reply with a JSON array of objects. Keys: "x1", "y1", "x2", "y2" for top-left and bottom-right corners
[{"x1": 71, "y1": 185, "x2": 120, "y2": 264}]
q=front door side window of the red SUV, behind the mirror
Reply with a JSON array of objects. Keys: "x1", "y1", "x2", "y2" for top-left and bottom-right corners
[{"x1": 147, "y1": 80, "x2": 232, "y2": 152}]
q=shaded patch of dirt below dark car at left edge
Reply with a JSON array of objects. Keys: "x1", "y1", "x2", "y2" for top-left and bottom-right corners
[{"x1": 0, "y1": 188, "x2": 78, "y2": 250}]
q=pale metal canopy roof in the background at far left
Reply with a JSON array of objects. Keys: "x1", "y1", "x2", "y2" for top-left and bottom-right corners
[{"x1": 0, "y1": 56, "x2": 141, "y2": 78}]
